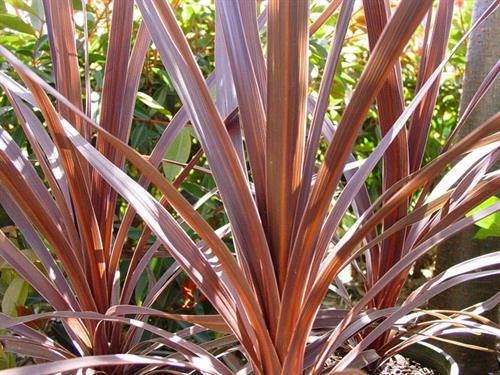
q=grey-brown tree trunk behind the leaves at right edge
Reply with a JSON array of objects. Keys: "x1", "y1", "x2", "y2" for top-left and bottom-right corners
[{"x1": 430, "y1": 0, "x2": 500, "y2": 375}]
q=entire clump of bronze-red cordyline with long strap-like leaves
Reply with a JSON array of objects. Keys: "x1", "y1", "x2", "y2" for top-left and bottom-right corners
[{"x1": 0, "y1": 0, "x2": 500, "y2": 374}]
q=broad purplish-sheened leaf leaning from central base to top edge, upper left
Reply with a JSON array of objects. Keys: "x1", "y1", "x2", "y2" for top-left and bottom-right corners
[{"x1": 137, "y1": 1, "x2": 279, "y2": 352}]
